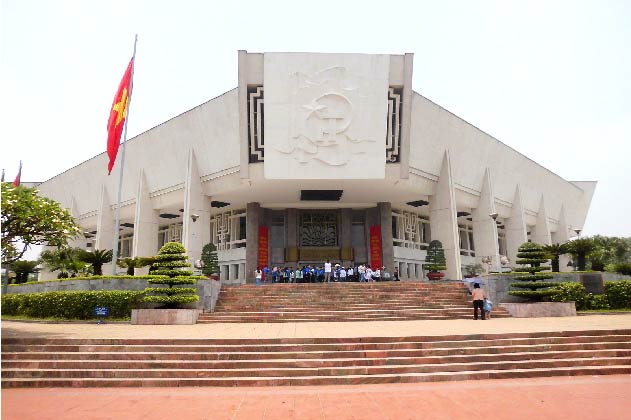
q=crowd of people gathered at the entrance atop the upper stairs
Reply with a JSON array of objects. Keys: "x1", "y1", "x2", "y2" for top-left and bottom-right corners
[{"x1": 254, "y1": 260, "x2": 399, "y2": 284}]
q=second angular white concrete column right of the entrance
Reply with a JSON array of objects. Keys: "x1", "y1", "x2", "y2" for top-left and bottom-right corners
[{"x1": 471, "y1": 168, "x2": 500, "y2": 267}]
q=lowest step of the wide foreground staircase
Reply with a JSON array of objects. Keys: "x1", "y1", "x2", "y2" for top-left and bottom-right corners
[{"x1": 2, "y1": 365, "x2": 631, "y2": 388}]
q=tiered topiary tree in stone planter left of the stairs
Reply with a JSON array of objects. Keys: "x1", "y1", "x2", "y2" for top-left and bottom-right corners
[{"x1": 143, "y1": 242, "x2": 199, "y2": 309}]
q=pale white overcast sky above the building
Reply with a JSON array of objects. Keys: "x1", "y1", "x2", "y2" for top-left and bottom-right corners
[{"x1": 0, "y1": 0, "x2": 631, "y2": 236}]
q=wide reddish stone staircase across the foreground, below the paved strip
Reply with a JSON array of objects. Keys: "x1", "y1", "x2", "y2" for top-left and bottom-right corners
[{"x1": 2, "y1": 329, "x2": 631, "y2": 388}]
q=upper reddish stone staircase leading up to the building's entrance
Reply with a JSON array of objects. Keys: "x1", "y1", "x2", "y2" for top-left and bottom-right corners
[{"x1": 198, "y1": 282, "x2": 510, "y2": 323}]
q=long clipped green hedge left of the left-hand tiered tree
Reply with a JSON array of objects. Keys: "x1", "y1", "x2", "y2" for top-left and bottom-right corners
[{"x1": 2, "y1": 290, "x2": 143, "y2": 319}]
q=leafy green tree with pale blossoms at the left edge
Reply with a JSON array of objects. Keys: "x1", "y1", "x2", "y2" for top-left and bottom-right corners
[{"x1": 2, "y1": 182, "x2": 79, "y2": 264}]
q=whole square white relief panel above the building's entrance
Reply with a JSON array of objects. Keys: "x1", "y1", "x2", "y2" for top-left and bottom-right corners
[{"x1": 265, "y1": 53, "x2": 389, "y2": 179}]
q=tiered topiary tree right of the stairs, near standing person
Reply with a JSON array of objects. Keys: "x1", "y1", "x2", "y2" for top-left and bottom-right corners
[{"x1": 508, "y1": 242, "x2": 555, "y2": 302}]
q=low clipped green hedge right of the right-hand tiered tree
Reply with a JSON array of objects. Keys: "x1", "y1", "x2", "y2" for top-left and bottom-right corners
[{"x1": 550, "y1": 280, "x2": 631, "y2": 310}]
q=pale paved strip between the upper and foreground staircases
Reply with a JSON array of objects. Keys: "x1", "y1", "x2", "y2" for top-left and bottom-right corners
[{"x1": 2, "y1": 314, "x2": 631, "y2": 339}]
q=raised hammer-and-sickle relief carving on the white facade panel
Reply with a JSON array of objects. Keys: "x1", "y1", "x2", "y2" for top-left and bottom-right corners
[{"x1": 277, "y1": 66, "x2": 375, "y2": 166}]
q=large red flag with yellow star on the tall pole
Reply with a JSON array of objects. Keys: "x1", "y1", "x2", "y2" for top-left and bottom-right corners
[{"x1": 107, "y1": 58, "x2": 134, "y2": 175}]
